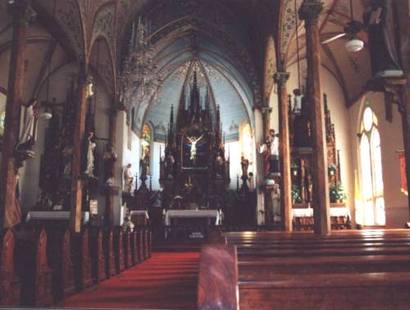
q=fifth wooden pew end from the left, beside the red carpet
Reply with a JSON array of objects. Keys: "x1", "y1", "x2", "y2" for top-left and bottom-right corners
[{"x1": 90, "y1": 228, "x2": 107, "y2": 283}]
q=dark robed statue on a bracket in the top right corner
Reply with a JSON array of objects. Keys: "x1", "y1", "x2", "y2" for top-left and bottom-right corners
[{"x1": 363, "y1": 0, "x2": 403, "y2": 77}]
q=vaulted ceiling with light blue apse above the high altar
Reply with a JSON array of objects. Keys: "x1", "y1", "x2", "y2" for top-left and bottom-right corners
[{"x1": 121, "y1": 1, "x2": 270, "y2": 137}]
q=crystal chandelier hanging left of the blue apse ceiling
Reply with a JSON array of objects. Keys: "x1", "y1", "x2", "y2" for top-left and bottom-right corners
[{"x1": 121, "y1": 16, "x2": 161, "y2": 106}]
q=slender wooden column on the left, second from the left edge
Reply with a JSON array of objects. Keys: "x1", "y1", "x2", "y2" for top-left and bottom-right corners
[{"x1": 70, "y1": 69, "x2": 87, "y2": 233}]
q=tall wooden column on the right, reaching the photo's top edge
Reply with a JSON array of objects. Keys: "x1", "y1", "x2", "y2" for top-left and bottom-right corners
[{"x1": 299, "y1": 0, "x2": 331, "y2": 235}]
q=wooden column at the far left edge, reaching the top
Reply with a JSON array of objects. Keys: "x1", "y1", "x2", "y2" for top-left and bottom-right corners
[{"x1": 0, "y1": 0, "x2": 29, "y2": 227}]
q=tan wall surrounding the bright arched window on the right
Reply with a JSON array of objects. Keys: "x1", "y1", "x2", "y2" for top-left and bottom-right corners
[{"x1": 349, "y1": 92, "x2": 409, "y2": 228}]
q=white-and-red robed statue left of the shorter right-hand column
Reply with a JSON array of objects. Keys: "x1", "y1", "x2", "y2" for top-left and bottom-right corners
[{"x1": 259, "y1": 129, "x2": 279, "y2": 175}]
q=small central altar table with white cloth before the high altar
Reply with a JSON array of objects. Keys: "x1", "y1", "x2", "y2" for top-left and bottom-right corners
[{"x1": 163, "y1": 209, "x2": 223, "y2": 239}]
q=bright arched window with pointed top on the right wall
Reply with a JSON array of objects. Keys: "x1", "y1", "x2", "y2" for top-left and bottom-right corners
[{"x1": 358, "y1": 106, "x2": 386, "y2": 225}]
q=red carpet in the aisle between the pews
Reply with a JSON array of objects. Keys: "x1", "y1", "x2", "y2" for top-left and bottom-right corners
[{"x1": 62, "y1": 252, "x2": 199, "y2": 310}]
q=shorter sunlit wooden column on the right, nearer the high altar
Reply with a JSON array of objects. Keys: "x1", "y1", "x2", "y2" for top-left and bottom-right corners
[{"x1": 274, "y1": 72, "x2": 292, "y2": 231}]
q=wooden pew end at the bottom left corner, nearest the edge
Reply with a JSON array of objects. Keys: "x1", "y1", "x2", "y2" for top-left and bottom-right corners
[{"x1": 0, "y1": 230, "x2": 21, "y2": 307}]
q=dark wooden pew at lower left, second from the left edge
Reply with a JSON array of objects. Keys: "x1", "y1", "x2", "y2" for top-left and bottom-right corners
[{"x1": 15, "y1": 229, "x2": 53, "y2": 307}]
